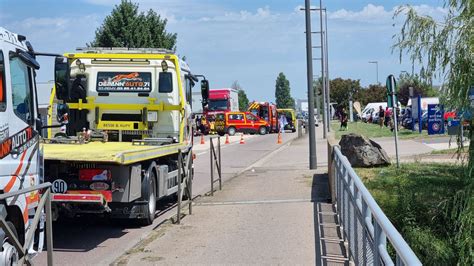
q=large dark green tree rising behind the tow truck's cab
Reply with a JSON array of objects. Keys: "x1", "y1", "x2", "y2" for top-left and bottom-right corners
[{"x1": 88, "y1": 0, "x2": 177, "y2": 51}]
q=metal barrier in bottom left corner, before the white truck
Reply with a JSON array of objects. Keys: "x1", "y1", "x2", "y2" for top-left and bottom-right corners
[{"x1": 0, "y1": 182, "x2": 53, "y2": 266}]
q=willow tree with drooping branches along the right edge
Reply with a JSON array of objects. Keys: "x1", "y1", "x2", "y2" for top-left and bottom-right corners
[{"x1": 393, "y1": 0, "x2": 474, "y2": 265}]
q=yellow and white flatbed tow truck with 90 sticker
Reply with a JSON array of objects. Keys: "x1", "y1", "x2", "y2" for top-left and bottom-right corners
[{"x1": 44, "y1": 47, "x2": 209, "y2": 224}]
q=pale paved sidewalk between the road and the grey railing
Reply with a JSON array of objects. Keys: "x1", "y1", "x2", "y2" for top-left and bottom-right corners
[{"x1": 112, "y1": 130, "x2": 348, "y2": 265}]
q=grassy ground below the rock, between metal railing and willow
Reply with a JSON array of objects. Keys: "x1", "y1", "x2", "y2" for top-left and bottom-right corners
[{"x1": 356, "y1": 163, "x2": 465, "y2": 265}]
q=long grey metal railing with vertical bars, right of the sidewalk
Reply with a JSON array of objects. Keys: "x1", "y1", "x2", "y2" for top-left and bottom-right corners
[{"x1": 333, "y1": 146, "x2": 422, "y2": 266}]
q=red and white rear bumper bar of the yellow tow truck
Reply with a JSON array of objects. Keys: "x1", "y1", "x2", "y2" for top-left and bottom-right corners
[{"x1": 52, "y1": 190, "x2": 112, "y2": 206}]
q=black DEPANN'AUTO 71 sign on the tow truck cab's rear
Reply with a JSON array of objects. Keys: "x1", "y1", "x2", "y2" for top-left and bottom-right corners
[{"x1": 97, "y1": 72, "x2": 151, "y2": 92}]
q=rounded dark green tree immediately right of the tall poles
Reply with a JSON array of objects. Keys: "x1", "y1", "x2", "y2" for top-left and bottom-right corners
[{"x1": 329, "y1": 78, "x2": 362, "y2": 109}]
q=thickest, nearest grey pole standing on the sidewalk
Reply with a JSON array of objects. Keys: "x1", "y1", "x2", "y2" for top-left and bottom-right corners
[{"x1": 305, "y1": 0, "x2": 317, "y2": 169}]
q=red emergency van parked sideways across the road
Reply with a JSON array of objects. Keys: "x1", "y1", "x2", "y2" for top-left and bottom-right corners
[{"x1": 216, "y1": 112, "x2": 269, "y2": 136}]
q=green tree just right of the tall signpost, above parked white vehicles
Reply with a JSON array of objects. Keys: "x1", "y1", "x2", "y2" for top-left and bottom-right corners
[{"x1": 397, "y1": 73, "x2": 439, "y2": 105}]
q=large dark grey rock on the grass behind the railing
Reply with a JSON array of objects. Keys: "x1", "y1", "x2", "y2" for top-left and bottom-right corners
[{"x1": 339, "y1": 133, "x2": 390, "y2": 167}]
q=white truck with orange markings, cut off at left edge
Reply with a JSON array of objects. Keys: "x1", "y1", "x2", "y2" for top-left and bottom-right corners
[{"x1": 0, "y1": 27, "x2": 43, "y2": 265}]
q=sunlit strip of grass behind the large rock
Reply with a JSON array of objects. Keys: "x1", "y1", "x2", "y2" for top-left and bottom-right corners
[{"x1": 331, "y1": 122, "x2": 428, "y2": 139}]
